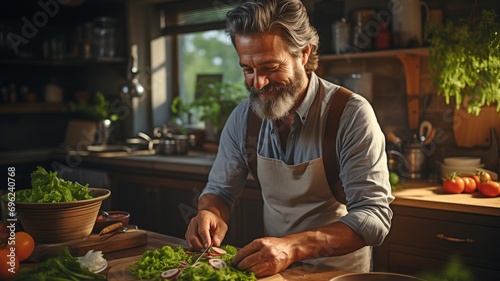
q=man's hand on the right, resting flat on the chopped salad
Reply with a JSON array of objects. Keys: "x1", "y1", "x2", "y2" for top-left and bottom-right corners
[{"x1": 233, "y1": 237, "x2": 295, "y2": 277}]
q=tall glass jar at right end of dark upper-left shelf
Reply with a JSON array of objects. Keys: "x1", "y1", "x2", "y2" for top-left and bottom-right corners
[{"x1": 93, "y1": 17, "x2": 116, "y2": 57}]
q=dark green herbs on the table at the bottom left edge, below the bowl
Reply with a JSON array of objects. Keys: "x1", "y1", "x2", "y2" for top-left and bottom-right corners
[{"x1": 12, "y1": 248, "x2": 106, "y2": 281}]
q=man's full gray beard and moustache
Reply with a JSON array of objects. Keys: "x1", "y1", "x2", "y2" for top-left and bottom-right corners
[{"x1": 245, "y1": 71, "x2": 303, "y2": 120}]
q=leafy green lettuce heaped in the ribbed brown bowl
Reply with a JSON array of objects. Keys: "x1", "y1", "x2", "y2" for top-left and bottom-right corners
[{"x1": 4, "y1": 166, "x2": 93, "y2": 203}]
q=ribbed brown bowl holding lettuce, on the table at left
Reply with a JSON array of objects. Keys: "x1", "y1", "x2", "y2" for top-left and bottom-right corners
[{"x1": 16, "y1": 188, "x2": 111, "y2": 243}]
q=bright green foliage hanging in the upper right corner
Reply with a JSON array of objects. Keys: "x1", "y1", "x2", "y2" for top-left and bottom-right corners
[{"x1": 425, "y1": 10, "x2": 500, "y2": 115}]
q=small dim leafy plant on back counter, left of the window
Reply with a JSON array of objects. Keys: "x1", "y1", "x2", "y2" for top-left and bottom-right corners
[{"x1": 70, "y1": 92, "x2": 118, "y2": 121}]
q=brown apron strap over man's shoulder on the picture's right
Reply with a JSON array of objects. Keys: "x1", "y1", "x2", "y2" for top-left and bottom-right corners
[{"x1": 323, "y1": 87, "x2": 352, "y2": 204}]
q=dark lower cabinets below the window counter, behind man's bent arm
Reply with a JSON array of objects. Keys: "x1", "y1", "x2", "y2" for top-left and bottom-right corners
[{"x1": 112, "y1": 172, "x2": 263, "y2": 247}]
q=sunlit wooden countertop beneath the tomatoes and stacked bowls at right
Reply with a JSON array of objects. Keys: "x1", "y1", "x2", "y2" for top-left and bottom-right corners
[{"x1": 392, "y1": 180, "x2": 500, "y2": 216}]
